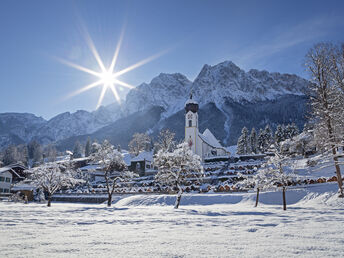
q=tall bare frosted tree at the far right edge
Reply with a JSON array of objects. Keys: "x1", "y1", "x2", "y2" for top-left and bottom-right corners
[{"x1": 306, "y1": 43, "x2": 344, "y2": 197}]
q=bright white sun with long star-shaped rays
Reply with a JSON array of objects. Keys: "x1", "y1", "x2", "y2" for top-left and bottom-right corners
[{"x1": 58, "y1": 27, "x2": 166, "y2": 109}]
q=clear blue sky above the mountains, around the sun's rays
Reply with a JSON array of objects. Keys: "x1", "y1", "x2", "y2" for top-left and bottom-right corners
[{"x1": 0, "y1": 0, "x2": 344, "y2": 119}]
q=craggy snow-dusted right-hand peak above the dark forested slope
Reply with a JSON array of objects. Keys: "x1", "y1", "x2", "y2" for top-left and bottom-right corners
[{"x1": 192, "y1": 61, "x2": 308, "y2": 105}]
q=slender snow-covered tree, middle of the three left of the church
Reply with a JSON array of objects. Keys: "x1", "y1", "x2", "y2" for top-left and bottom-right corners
[{"x1": 91, "y1": 140, "x2": 137, "y2": 207}]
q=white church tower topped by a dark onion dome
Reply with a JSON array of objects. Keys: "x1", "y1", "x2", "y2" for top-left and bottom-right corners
[{"x1": 185, "y1": 94, "x2": 202, "y2": 157}]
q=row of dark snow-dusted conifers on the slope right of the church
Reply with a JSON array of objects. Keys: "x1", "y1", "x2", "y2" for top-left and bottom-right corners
[{"x1": 237, "y1": 123, "x2": 299, "y2": 154}]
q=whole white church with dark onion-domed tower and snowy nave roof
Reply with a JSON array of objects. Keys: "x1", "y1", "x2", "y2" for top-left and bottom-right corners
[{"x1": 185, "y1": 94, "x2": 229, "y2": 161}]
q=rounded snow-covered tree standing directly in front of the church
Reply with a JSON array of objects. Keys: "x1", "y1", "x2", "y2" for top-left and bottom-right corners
[{"x1": 154, "y1": 142, "x2": 204, "y2": 209}]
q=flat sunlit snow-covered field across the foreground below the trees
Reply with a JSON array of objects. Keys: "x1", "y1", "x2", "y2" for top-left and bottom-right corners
[{"x1": 0, "y1": 183, "x2": 344, "y2": 257}]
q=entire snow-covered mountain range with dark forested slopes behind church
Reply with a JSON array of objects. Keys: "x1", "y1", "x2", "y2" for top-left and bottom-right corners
[{"x1": 0, "y1": 61, "x2": 309, "y2": 148}]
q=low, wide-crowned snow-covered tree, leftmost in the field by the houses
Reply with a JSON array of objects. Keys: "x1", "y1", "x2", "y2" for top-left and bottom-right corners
[{"x1": 26, "y1": 162, "x2": 81, "y2": 207}]
